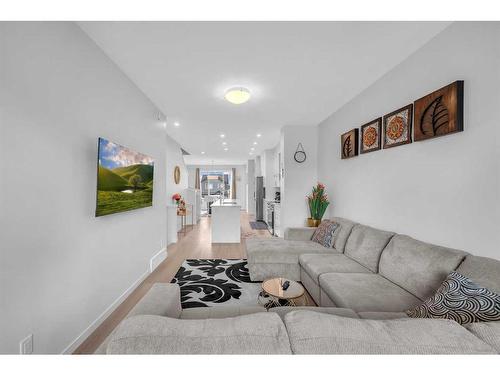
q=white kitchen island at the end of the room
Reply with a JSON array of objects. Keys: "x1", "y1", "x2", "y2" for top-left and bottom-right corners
[{"x1": 211, "y1": 199, "x2": 241, "y2": 243}]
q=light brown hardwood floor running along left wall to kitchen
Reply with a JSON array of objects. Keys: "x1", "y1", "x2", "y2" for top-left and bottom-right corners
[{"x1": 73, "y1": 211, "x2": 314, "y2": 354}]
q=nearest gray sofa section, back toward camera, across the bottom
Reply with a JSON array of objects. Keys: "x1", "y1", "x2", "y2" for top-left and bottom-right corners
[{"x1": 101, "y1": 284, "x2": 500, "y2": 354}]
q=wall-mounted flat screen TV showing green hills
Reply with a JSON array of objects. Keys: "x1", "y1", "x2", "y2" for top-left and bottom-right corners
[{"x1": 95, "y1": 138, "x2": 154, "y2": 216}]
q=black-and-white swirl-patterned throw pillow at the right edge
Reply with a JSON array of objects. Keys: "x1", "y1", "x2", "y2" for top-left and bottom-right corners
[{"x1": 406, "y1": 272, "x2": 500, "y2": 324}]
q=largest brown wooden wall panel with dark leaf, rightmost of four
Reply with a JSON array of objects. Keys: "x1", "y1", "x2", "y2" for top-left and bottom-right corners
[{"x1": 414, "y1": 81, "x2": 464, "y2": 142}]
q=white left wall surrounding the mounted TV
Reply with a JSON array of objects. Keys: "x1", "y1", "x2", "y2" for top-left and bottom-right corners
[{"x1": 0, "y1": 22, "x2": 166, "y2": 353}]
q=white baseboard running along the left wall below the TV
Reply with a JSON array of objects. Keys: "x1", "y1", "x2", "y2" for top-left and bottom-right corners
[{"x1": 61, "y1": 248, "x2": 167, "y2": 354}]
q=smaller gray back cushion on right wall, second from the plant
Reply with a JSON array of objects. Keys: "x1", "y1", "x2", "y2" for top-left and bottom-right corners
[{"x1": 344, "y1": 224, "x2": 394, "y2": 272}]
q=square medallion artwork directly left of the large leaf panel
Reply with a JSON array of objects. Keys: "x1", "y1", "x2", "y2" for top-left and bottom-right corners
[{"x1": 383, "y1": 104, "x2": 413, "y2": 148}]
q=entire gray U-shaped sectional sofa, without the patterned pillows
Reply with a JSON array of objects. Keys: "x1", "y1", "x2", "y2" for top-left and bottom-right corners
[{"x1": 97, "y1": 218, "x2": 500, "y2": 354}]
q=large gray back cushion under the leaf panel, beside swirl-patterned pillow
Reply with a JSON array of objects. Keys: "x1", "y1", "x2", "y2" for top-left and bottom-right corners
[{"x1": 379, "y1": 234, "x2": 466, "y2": 300}]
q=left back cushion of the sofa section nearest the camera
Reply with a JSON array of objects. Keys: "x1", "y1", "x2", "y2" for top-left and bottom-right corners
[{"x1": 107, "y1": 312, "x2": 290, "y2": 354}]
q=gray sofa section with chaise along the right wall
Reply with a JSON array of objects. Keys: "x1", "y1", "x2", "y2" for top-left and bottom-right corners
[{"x1": 247, "y1": 218, "x2": 500, "y2": 312}]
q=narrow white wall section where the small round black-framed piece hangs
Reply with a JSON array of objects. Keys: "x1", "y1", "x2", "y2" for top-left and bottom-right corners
[{"x1": 281, "y1": 126, "x2": 318, "y2": 233}]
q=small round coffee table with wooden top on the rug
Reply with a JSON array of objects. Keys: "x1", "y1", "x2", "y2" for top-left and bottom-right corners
[{"x1": 259, "y1": 277, "x2": 305, "y2": 309}]
